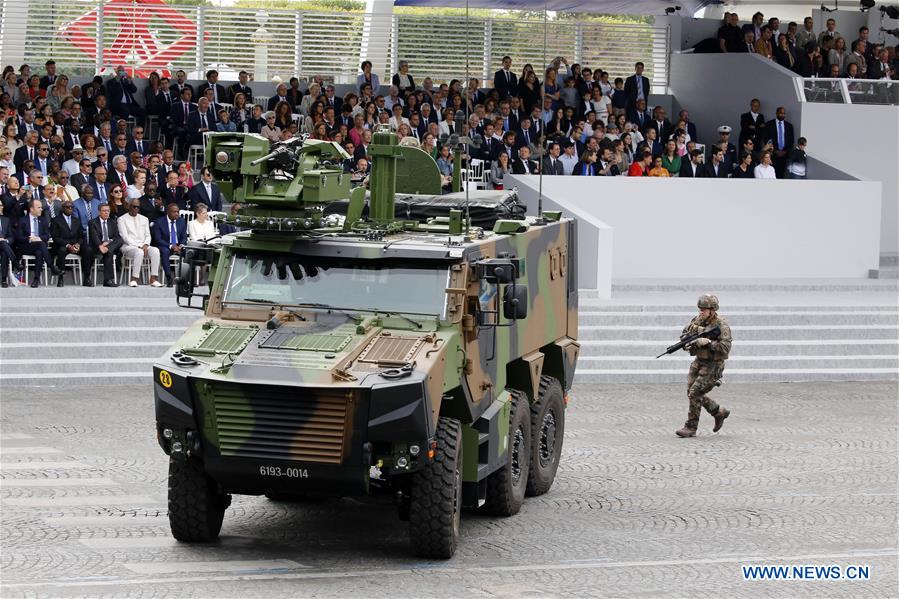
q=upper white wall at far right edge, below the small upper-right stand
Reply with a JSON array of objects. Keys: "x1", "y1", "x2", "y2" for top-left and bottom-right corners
[{"x1": 802, "y1": 103, "x2": 899, "y2": 253}]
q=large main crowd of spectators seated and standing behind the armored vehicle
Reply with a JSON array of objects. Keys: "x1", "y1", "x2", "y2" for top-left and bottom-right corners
[{"x1": 0, "y1": 31, "x2": 836, "y2": 287}]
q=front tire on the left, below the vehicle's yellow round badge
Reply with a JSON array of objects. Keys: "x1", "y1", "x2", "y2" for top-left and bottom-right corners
[{"x1": 169, "y1": 458, "x2": 231, "y2": 543}]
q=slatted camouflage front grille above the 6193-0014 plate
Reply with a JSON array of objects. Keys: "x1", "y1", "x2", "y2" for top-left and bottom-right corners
[{"x1": 210, "y1": 383, "x2": 353, "y2": 464}]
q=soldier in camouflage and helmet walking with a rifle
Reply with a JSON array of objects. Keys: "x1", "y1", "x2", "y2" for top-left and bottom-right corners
[{"x1": 675, "y1": 295, "x2": 732, "y2": 437}]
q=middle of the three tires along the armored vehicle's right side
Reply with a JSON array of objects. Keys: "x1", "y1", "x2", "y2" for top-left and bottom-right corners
[{"x1": 484, "y1": 391, "x2": 531, "y2": 516}]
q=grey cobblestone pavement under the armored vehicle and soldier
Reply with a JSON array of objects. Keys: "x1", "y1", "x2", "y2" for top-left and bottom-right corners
[{"x1": 0, "y1": 383, "x2": 899, "y2": 598}]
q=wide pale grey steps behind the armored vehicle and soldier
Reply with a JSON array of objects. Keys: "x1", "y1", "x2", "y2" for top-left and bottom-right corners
[{"x1": 0, "y1": 279, "x2": 899, "y2": 386}]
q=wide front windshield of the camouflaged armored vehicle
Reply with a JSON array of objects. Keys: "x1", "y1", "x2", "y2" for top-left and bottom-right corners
[{"x1": 224, "y1": 253, "x2": 449, "y2": 319}]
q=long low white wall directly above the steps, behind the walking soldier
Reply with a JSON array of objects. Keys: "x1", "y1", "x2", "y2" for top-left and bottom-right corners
[{"x1": 513, "y1": 175, "x2": 880, "y2": 279}]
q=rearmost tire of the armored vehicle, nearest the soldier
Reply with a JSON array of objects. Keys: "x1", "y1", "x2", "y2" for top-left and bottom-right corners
[{"x1": 527, "y1": 376, "x2": 565, "y2": 496}]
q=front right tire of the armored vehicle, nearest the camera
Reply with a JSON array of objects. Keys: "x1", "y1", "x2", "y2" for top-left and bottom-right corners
[{"x1": 409, "y1": 418, "x2": 462, "y2": 559}]
